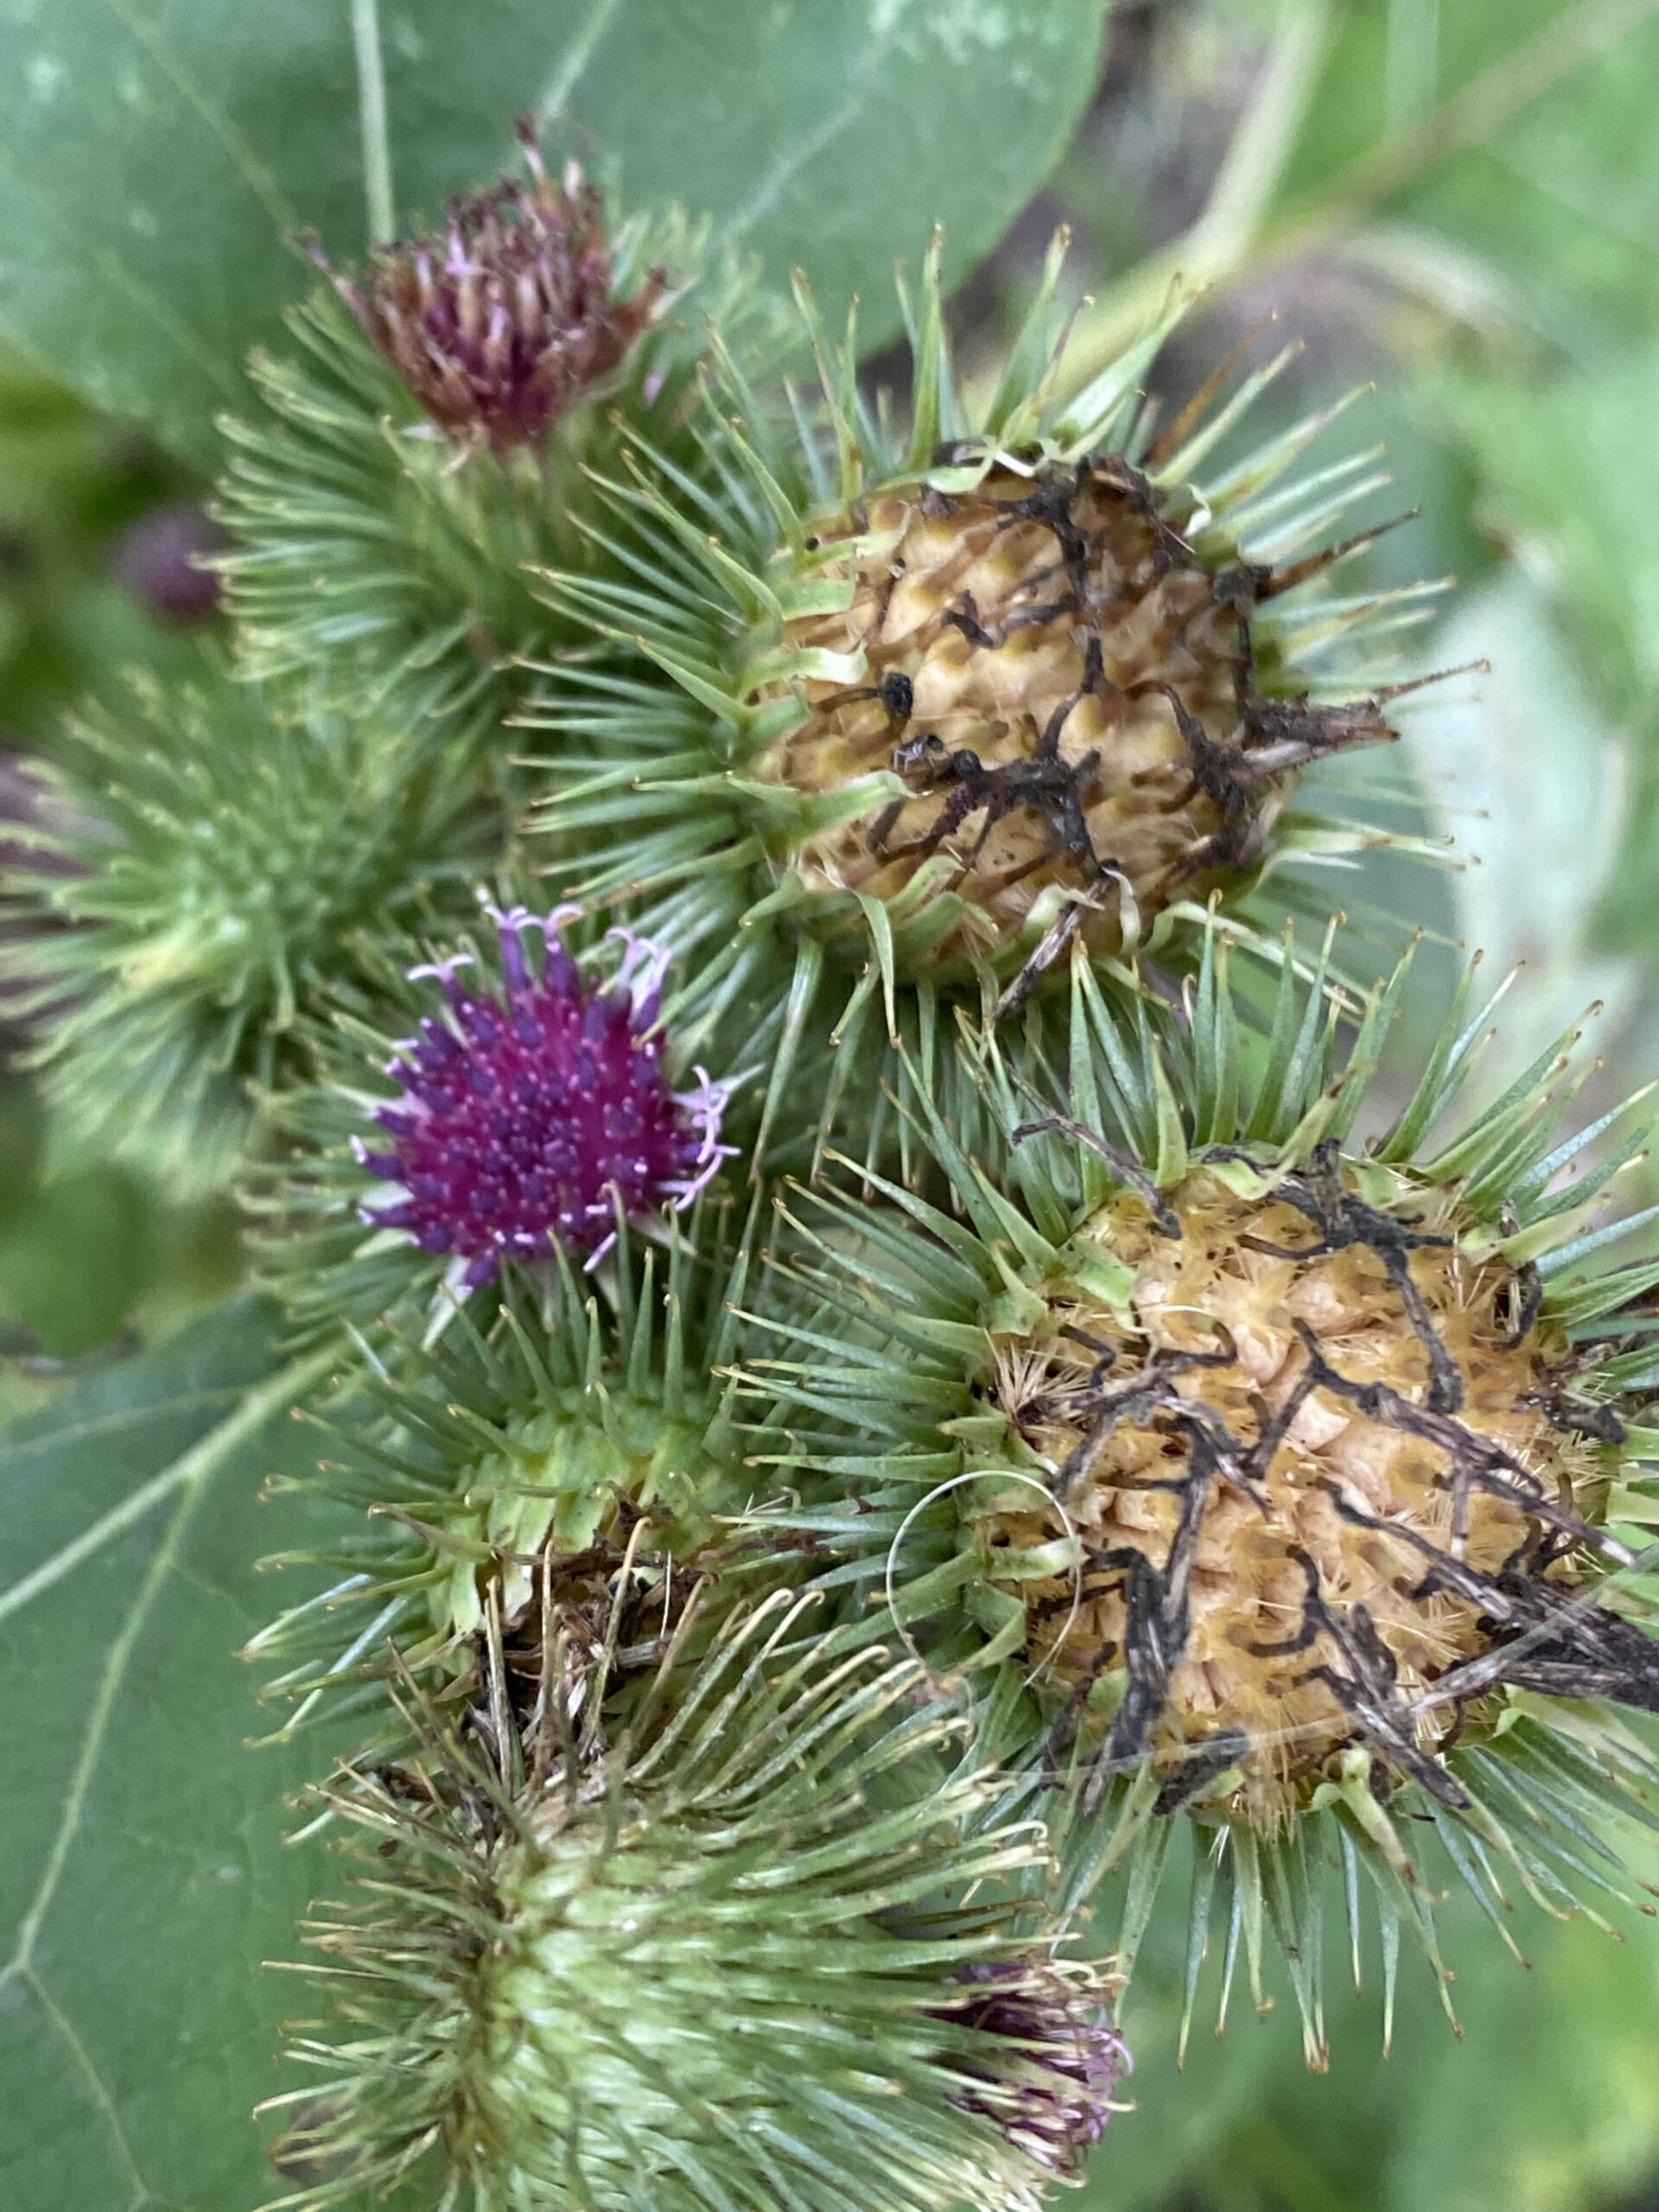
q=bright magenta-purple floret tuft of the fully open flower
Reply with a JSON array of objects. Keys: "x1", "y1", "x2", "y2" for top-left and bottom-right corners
[{"x1": 354, "y1": 907, "x2": 736, "y2": 1289}]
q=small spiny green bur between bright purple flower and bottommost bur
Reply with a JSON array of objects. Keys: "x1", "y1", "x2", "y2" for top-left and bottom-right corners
[{"x1": 250, "y1": 1197, "x2": 757, "y2": 1727}]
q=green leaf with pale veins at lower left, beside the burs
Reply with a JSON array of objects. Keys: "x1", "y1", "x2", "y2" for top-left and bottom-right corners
[{"x1": 0, "y1": 1299, "x2": 345, "y2": 2212}]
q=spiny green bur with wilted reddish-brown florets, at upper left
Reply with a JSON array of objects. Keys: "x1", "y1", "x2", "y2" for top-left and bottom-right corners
[{"x1": 219, "y1": 133, "x2": 781, "y2": 716}]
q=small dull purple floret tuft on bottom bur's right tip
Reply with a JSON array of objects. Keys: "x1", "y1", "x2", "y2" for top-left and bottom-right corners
[{"x1": 938, "y1": 1960, "x2": 1130, "y2": 2174}]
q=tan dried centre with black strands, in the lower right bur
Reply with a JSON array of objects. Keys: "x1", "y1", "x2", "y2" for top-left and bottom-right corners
[{"x1": 980, "y1": 1150, "x2": 1628, "y2": 1827}]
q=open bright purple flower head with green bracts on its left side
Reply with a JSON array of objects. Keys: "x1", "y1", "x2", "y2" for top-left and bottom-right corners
[{"x1": 258, "y1": 900, "x2": 736, "y2": 1320}]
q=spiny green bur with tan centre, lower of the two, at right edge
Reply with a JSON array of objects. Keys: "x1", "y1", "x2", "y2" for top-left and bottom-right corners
[{"x1": 757, "y1": 938, "x2": 1659, "y2": 2063}]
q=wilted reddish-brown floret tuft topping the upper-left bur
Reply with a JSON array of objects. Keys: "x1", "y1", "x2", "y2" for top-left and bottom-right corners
[{"x1": 309, "y1": 122, "x2": 666, "y2": 451}]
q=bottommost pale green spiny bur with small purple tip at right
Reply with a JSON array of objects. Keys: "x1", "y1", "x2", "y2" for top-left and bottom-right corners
[{"x1": 274, "y1": 1599, "x2": 1117, "y2": 2212}]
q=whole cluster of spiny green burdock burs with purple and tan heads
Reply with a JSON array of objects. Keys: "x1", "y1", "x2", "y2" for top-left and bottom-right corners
[{"x1": 13, "y1": 55, "x2": 1659, "y2": 2212}]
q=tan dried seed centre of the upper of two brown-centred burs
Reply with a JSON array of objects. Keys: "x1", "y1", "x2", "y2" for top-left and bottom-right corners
[{"x1": 754, "y1": 454, "x2": 1395, "y2": 964}]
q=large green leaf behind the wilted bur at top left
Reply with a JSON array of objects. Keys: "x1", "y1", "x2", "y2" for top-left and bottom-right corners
[{"x1": 0, "y1": 0, "x2": 1106, "y2": 458}]
